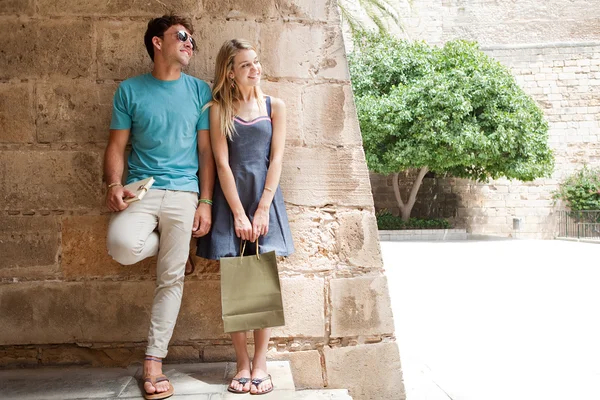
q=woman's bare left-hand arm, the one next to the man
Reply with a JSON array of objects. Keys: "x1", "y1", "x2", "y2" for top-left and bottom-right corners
[{"x1": 210, "y1": 104, "x2": 254, "y2": 240}]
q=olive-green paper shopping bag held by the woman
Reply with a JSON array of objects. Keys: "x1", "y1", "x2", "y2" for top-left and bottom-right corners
[{"x1": 221, "y1": 241, "x2": 285, "y2": 333}]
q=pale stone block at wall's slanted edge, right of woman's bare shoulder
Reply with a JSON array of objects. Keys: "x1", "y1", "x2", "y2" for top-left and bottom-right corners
[{"x1": 302, "y1": 83, "x2": 362, "y2": 146}]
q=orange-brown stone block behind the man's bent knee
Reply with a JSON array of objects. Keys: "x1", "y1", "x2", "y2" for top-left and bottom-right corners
[{"x1": 61, "y1": 215, "x2": 156, "y2": 279}]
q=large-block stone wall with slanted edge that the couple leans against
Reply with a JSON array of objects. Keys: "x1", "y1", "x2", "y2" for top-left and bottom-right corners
[{"x1": 0, "y1": 0, "x2": 402, "y2": 399}]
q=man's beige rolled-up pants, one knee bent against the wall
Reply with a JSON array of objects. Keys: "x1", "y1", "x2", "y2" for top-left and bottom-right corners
[{"x1": 107, "y1": 189, "x2": 198, "y2": 358}]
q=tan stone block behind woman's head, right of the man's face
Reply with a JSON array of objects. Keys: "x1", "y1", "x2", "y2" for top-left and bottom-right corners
[{"x1": 188, "y1": 19, "x2": 261, "y2": 81}]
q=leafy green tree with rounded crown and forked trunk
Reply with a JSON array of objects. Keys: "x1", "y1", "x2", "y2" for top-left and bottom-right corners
[{"x1": 349, "y1": 32, "x2": 554, "y2": 220}]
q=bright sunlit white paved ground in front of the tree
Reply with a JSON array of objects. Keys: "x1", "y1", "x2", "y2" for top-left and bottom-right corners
[{"x1": 381, "y1": 240, "x2": 600, "y2": 400}]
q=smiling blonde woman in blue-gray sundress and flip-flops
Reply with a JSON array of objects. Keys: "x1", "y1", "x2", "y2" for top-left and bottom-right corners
[{"x1": 197, "y1": 39, "x2": 294, "y2": 394}]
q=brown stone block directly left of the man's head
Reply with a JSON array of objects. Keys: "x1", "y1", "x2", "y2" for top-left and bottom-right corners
[{"x1": 96, "y1": 20, "x2": 152, "y2": 80}]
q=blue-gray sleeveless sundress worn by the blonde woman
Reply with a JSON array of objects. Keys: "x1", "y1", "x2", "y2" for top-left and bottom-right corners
[{"x1": 196, "y1": 96, "x2": 294, "y2": 260}]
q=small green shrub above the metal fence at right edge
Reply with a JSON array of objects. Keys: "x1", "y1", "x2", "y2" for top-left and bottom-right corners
[{"x1": 553, "y1": 165, "x2": 600, "y2": 211}]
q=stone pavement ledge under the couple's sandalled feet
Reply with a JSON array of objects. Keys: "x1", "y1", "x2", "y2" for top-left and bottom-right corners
[{"x1": 0, "y1": 361, "x2": 352, "y2": 400}]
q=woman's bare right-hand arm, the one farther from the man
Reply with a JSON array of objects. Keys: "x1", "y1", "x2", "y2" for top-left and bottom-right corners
[{"x1": 252, "y1": 97, "x2": 286, "y2": 237}]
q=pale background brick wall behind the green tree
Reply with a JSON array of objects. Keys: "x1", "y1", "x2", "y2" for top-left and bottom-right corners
[{"x1": 371, "y1": 0, "x2": 600, "y2": 238}]
